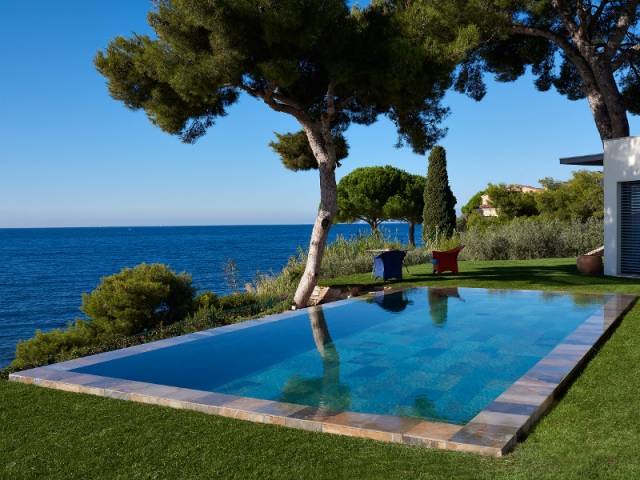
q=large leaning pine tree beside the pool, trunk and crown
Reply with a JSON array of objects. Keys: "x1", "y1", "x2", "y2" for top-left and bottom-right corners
[{"x1": 95, "y1": 0, "x2": 473, "y2": 306}]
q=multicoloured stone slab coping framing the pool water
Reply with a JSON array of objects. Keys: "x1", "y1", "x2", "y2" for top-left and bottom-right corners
[{"x1": 9, "y1": 287, "x2": 637, "y2": 457}]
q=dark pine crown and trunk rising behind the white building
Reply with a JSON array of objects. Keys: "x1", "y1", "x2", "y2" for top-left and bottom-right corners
[{"x1": 450, "y1": 0, "x2": 640, "y2": 140}]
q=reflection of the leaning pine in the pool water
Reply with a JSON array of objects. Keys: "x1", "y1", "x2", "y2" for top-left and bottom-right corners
[{"x1": 281, "y1": 308, "x2": 351, "y2": 411}]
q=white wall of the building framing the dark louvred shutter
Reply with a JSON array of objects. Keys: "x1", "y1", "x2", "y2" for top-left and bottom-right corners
[{"x1": 604, "y1": 137, "x2": 640, "y2": 275}]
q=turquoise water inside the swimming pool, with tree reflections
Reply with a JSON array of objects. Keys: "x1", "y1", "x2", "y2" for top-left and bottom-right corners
[{"x1": 74, "y1": 288, "x2": 609, "y2": 424}]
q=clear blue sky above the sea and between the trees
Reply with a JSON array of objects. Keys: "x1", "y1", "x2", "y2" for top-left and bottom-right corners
[{"x1": 0, "y1": 0, "x2": 640, "y2": 228}]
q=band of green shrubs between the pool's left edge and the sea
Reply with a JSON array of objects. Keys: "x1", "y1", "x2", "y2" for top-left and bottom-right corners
[{"x1": 10, "y1": 234, "x2": 436, "y2": 370}]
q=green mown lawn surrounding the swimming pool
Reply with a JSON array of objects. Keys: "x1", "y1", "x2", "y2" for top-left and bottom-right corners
[{"x1": 0, "y1": 260, "x2": 640, "y2": 479}]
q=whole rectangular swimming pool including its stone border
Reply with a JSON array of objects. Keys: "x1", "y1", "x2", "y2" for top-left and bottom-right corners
[{"x1": 15, "y1": 287, "x2": 632, "y2": 454}]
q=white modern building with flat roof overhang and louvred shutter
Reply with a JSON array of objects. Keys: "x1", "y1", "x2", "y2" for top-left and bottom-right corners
[{"x1": 560, "y1": 137, "x2": 640, "y2": 276}]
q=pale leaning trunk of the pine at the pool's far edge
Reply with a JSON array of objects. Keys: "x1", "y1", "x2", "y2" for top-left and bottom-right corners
[{"x1": 293, "y1": 126, "x2": 338, "y2": 308}]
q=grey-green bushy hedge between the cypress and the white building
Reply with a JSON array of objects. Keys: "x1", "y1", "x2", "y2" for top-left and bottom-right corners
[{"x1": 460, "y1": 217, "x2": 604, "y2": 260}]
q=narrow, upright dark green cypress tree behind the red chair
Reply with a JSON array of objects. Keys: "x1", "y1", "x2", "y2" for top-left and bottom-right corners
[{"x1": 422, "y1": 146, "x2": 456, "y2": 243}]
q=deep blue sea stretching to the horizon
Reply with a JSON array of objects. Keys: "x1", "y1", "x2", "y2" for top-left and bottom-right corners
[{"x1": 0, "y1": 224, "x2": 420, "y2": 367}]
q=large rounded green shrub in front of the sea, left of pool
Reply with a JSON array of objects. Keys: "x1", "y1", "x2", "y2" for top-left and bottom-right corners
[{"x1": 81, "y1": 263, "x2": 195, "y2": 336}]
